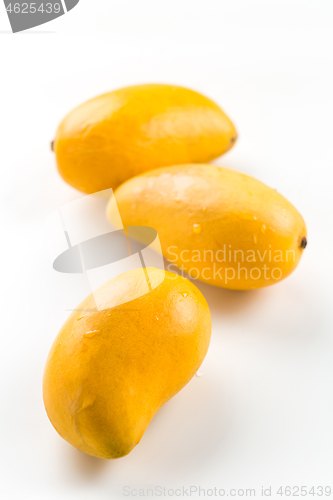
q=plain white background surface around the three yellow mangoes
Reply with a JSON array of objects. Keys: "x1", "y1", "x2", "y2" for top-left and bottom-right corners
[{"x1": 0, "y1": 0, "x2": 333, "y2": 500}]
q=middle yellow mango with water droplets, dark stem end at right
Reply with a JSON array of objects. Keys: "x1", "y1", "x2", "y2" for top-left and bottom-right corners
[{"x1": 107, "y1": 164, "x2": 307, "y2": 290}]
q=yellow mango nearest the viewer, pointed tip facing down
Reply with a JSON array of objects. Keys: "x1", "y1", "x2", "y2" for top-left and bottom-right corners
[{"x1": 43, "y1": 268, "x2": 211, "y2": 459}]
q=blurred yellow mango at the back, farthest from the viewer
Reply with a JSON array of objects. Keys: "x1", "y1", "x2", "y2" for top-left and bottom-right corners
[{"x1": 53, "y1": 84, "x2": 237, "y2": 193}]
